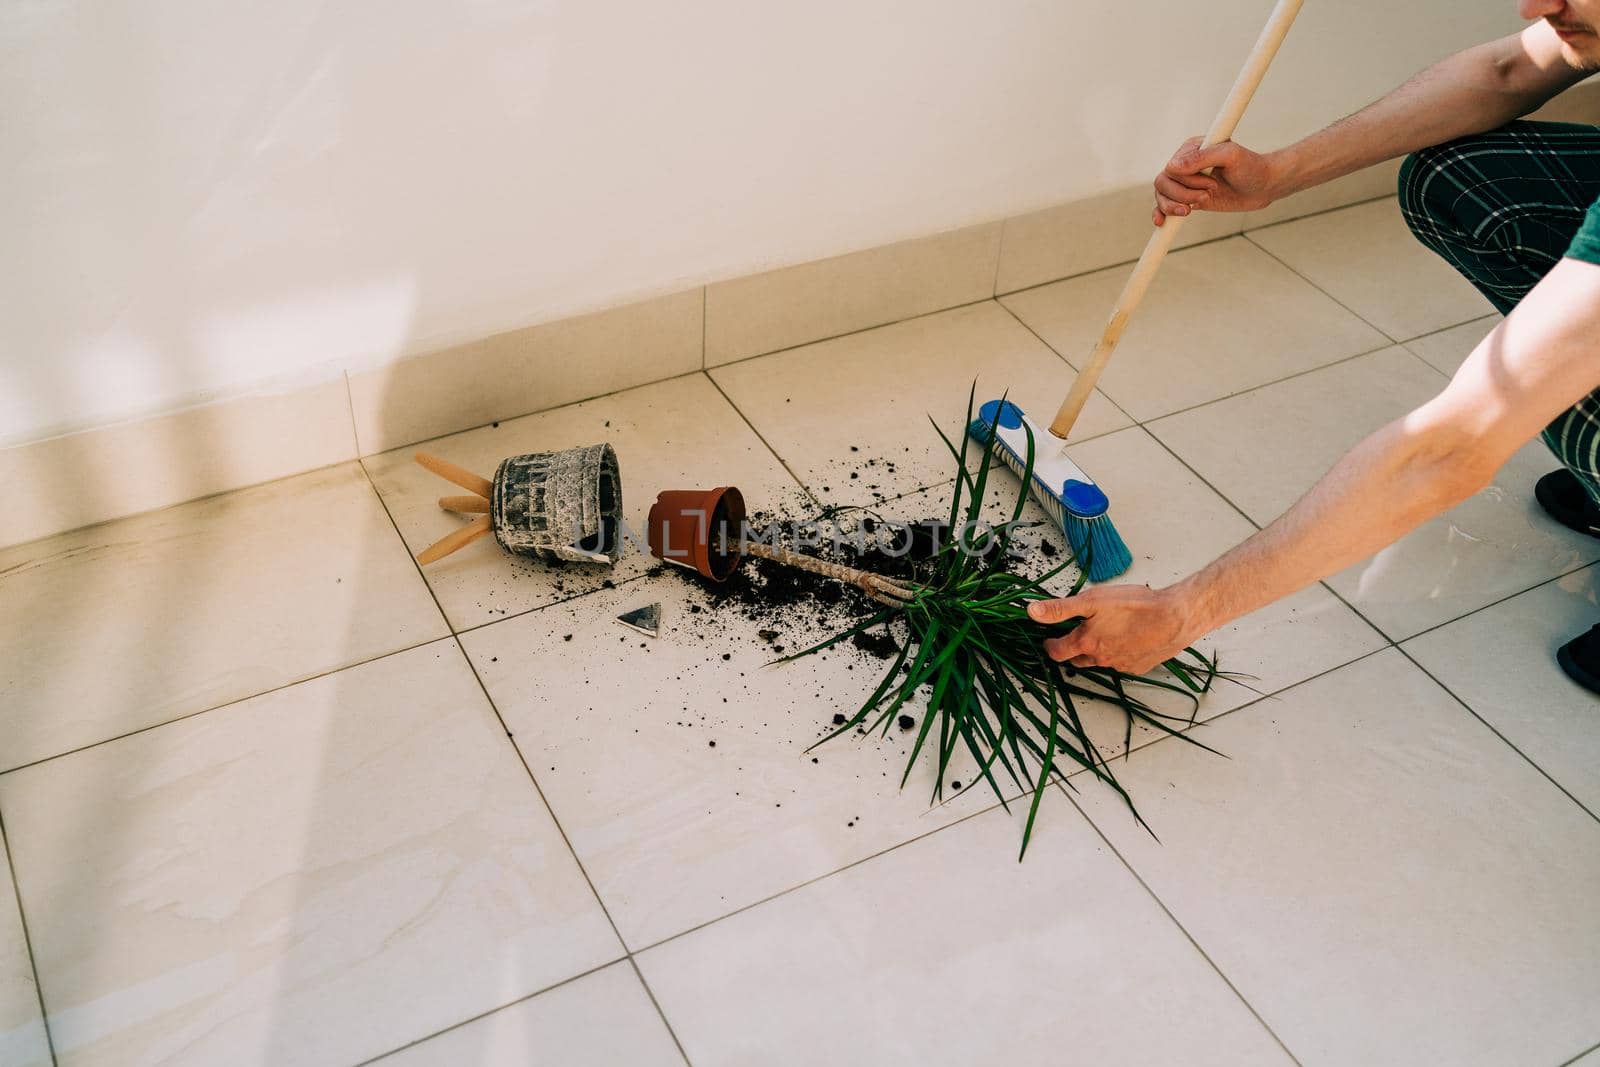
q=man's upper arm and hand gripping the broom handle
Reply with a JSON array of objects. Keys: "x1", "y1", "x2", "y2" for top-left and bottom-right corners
[{"x1": 1154, "y1": 21, "x2": 1586, "y2": 226}]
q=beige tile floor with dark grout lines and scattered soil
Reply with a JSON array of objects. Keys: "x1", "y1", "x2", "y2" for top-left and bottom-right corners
[{"x1": 0, "y1": 200, "x2": 1600, "y2": 1067}]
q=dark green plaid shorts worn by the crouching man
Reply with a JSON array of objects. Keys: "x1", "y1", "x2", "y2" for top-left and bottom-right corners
[{"x1": 1400, "y1": 122, "x2": 1600, "y2": 504}]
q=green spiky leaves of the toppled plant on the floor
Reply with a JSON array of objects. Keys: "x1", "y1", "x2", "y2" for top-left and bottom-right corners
[{"x1": 779, "y1": 388, "x2": 1219, "y2": 859}]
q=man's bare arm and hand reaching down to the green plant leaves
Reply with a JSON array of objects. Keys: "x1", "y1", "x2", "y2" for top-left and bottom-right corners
[{"x1": 1030, "y1": 259, "x2": 1600, "y2": 673}]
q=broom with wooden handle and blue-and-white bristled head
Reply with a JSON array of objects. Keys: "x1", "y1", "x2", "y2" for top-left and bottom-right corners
[{"x1": 966, "y1": 0, "x2": 1302, "y2": 582}]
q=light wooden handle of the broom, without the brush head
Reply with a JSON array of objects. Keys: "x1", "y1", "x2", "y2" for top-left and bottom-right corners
[{"x1": 1050, "y1": 0, "x2": 1304, "y2": 440}]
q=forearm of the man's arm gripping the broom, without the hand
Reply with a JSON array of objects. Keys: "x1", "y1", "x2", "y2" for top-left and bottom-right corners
[{"x1": 1267, "y1": 24, "x2": 1584, "y2": 197}]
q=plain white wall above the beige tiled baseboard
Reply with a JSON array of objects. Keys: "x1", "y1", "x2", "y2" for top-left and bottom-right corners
[{"x1": 0, "y1": 0, "x2": 1518, "y2": 443}]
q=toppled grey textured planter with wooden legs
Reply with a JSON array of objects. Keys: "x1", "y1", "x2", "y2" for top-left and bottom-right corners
[{"x1": 416, "y1": 445, "x2": 622, "y2": 563}]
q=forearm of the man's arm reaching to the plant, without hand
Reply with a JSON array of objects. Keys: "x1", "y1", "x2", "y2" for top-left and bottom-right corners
[{"x1": 1170, "y1": 413, "x2": 1491, "y2": 633}]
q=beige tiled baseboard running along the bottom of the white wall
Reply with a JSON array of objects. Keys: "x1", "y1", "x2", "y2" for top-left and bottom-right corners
[{"x1": 12, "y1": 80, "x2": 1600, "y2": 547}]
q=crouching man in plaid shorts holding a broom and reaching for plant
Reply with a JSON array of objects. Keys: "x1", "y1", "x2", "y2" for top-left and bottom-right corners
[{"x1": 1032, "y1": 0, "x2": 1600, "y2": 693}]
